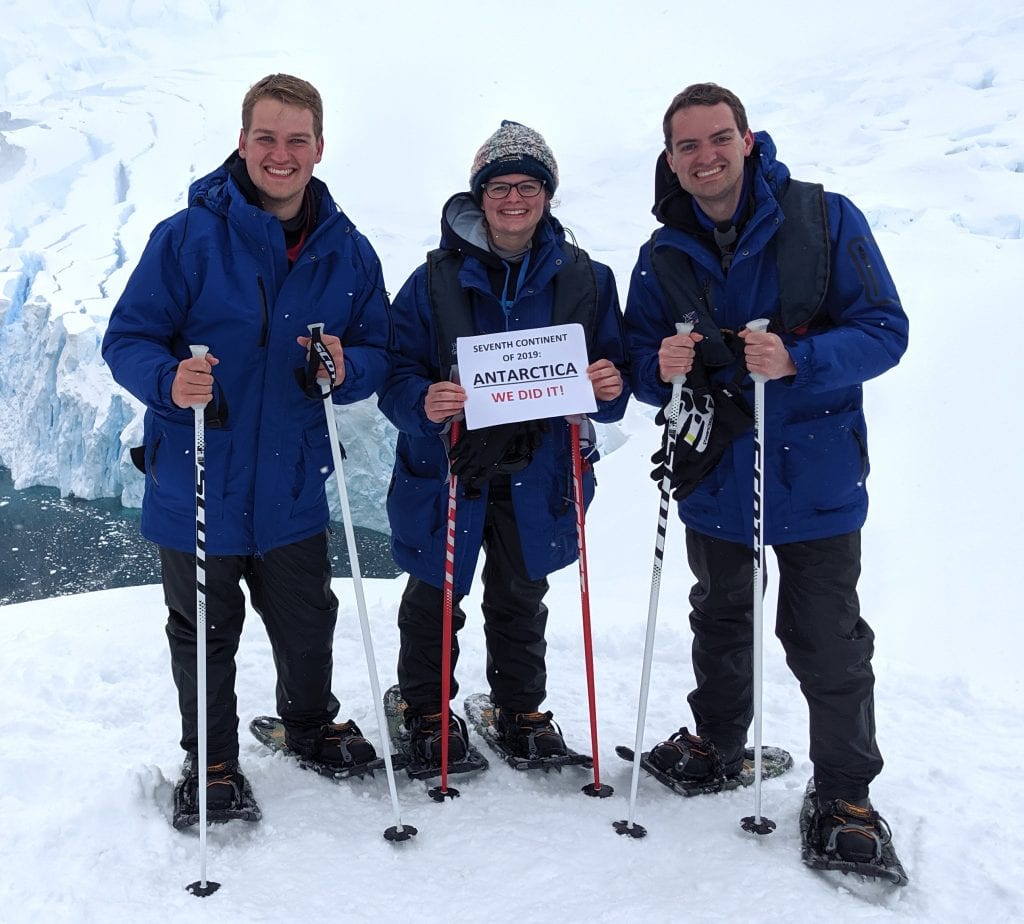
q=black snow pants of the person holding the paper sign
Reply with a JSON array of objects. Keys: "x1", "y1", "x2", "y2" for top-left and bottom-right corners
[{"x1": 398, "y1": 475, "x2": 548, "y2": 715}]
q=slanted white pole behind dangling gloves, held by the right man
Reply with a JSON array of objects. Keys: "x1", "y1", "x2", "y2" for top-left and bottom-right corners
[{"x1": 612, "y1": 323, "x2": 693, "y2": 838}]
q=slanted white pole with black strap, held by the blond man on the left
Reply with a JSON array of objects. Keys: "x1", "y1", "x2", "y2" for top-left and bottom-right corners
[{"x1": 308, "y1": 323, "x2": 417, "y2": 841}]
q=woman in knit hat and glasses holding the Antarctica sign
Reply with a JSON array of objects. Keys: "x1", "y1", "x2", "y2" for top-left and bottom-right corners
[{"x1": 380, "y1": 121, "x2": 629, "y2": 769}]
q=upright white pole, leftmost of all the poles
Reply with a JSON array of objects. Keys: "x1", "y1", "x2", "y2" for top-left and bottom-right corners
[{"x1": 185, "y1": 344, "x2": 220, "y2": 898}]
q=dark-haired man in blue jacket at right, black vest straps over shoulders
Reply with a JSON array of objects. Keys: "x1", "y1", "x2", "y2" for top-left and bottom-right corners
[{"x1": 625, "y1": 84, "x2": 907, "y2": 860}]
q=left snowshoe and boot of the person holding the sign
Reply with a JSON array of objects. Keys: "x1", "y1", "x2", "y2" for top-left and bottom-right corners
[{"x1": 384, "y1": 684, "x2": 487, "y2": 780}]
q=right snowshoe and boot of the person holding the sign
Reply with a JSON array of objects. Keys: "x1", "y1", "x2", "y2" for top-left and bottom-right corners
[{"x1": 465, "y1": 694, "x2": 594, "y2": 771}]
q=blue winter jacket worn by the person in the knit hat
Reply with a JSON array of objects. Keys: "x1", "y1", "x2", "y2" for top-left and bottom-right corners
[{"x1": 380, "y1": 194, "x2": 629, "y2": 593}]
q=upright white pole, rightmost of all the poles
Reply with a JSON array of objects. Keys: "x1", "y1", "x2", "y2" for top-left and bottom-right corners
[{"x1": 739, "y1": 318, "x2": 775, "y2": 834}]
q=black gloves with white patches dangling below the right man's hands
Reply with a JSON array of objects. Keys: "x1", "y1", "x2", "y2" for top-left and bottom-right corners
[{"x1": 650, "y1": 385, "x2": 754, "y2": 501}]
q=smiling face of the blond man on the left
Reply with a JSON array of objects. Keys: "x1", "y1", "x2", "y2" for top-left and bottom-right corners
[{"x1": 239, "y1": 96, "x2": 324, "y2": 221}]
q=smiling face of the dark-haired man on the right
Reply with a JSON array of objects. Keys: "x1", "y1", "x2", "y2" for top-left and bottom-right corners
[{"x1": 668, "y1": 102, "x2": 754, "y2": 221}]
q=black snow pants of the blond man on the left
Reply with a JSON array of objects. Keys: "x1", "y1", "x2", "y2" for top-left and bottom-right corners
[{"x1": 160, "y1": 532, "x2": 340, "y2": 764}]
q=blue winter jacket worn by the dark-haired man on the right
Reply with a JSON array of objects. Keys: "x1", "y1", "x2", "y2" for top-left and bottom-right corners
[{"x1": 625, "y1": 132, "x2": 907, "y2": 545}]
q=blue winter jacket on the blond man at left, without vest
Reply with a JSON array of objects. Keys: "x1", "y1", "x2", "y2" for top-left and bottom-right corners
[{"x1": 102, "y1": 158, "x2": 390, "y2": 555}]
